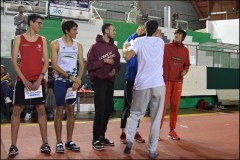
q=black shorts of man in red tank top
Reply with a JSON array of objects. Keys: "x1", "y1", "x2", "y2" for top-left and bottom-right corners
[{"x1": 13, "y1": 81, "x2": 46, "y2": 105}]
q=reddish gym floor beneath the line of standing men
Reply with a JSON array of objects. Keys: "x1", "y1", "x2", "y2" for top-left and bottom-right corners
[{"x1": 1, "y1": 107, "x2": 239, "y2": 159}]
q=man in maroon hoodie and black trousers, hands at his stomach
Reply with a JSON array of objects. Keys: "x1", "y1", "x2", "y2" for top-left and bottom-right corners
[{"x1": 86, "y1": 23, "x2": 120, "y2": 151}]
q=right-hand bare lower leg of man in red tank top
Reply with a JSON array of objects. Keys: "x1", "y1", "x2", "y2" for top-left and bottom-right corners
[{"x1": 36, "y1": 105, "x2": 48, "y2": 144}]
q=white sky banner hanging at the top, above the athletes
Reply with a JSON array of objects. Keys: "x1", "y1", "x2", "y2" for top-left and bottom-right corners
[{"x1": 49, "y1": 0, "x2": 90, "y2": 20}]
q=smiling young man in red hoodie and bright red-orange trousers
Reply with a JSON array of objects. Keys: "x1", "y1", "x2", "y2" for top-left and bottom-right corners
[{"x1": 159, "y1": 29, "x2": 190, "y2": 140}]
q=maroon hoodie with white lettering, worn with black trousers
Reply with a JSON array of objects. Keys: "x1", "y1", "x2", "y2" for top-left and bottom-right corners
[{"x1": 86, "y1": 35, "x2": 120, "y2": 81}]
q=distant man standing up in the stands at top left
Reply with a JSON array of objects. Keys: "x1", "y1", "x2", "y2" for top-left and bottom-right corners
[{"x1": 14, "y1": 6, "x2": 27, "y2": 36}]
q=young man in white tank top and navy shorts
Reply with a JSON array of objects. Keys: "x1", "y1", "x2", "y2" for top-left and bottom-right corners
[{"x1": 51, "y1": 20, "x2": 84, "y2": 153}]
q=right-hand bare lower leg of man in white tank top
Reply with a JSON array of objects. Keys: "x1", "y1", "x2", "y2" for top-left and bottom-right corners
[{"x1": 67, "y1": 104, "x2": 75, "y2": 141}]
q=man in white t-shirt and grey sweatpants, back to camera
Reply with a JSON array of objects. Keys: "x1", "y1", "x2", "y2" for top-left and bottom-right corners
[{"x1": 123, "y1": 20, "x2": 165, "y2": 158}]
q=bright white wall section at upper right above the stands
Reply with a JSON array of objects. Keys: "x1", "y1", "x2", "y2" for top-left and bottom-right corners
[{"x1": 206, "y1": 19, "x2": 239, "y2": 45}]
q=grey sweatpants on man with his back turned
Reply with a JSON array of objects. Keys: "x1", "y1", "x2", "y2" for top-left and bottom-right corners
[{"x1": 127, "y1": 86, "x2": 166, "y2": 153}]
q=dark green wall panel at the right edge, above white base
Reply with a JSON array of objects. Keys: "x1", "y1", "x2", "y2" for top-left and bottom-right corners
[{"x1": 207, "y1": 67, "x2": 239, "y2": 89}]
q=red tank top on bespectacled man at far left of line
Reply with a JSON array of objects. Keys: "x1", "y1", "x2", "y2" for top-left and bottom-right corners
[{"x1": 17, "y1": 35, "x2": 43, "y2": 81}]
